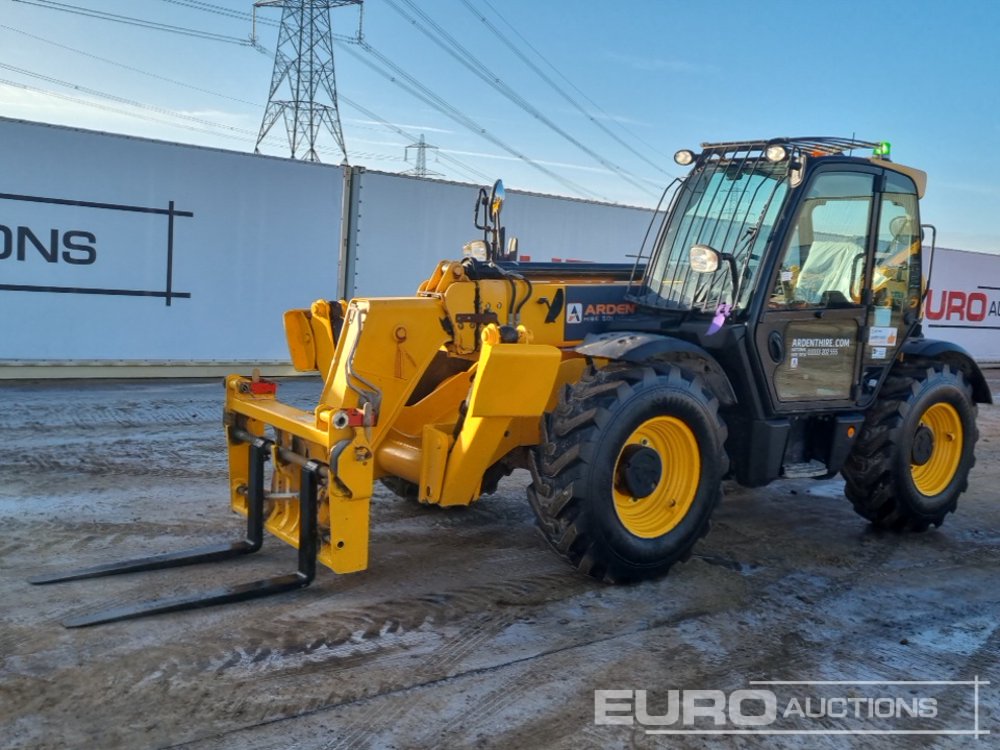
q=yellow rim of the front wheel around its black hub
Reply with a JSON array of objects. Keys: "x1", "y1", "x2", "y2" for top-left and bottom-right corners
[{"x1": 612, "y1": 417, "x2": 701, "y2": 539}]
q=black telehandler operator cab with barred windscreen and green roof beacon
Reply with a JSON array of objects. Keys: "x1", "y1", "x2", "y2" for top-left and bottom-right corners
[{"x1": 632, "y1": 138, "x2": 926, "y2": 416}]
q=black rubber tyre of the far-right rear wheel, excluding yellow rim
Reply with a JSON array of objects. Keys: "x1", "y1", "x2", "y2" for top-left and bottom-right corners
[{"x1": 841, "y1": 362, "x2": 979, "y2": 532}]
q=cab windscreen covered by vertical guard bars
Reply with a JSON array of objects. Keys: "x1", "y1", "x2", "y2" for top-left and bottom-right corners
[{"x1": 635, "y1": 152, "x2": 789, "y2": 310}]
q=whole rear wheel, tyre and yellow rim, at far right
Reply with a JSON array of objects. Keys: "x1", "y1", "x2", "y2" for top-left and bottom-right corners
[{"x1": 841, "y1": 363, "x2": 979, "y2": 531}]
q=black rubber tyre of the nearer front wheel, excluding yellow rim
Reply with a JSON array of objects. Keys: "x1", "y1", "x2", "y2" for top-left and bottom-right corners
[{"x1": 528, "y1": 363, "x2": 729, "y2": 583}]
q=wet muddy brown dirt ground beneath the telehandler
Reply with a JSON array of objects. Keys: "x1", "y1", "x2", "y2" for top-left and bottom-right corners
[{"x1": 0, "y1": 370, "x2": 1000, "y2": 750}]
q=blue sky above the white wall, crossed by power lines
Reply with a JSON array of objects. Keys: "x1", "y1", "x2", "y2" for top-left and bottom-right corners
[{"x1": 0, "y1": 0, "x2": 1000, "y2": 252}]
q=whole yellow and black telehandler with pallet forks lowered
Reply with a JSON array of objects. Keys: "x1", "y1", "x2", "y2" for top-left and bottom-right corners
[{"x1": 33, "y1": 137, "x2": 991, "y2": 626}]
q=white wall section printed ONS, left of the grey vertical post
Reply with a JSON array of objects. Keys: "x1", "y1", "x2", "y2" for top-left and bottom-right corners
[{"x1": 0, "y1": 118, "x2": 343, "y2": 370}]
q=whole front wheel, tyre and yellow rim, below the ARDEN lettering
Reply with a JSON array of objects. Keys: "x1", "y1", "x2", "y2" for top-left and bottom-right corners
[{"x1": 528, "y1": 363, "x2": 728, "y2": 583}]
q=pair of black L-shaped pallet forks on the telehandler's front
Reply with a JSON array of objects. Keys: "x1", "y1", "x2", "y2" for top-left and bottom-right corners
[{"x1": 29, "y1": 437, "x2": 320, "y2": 628}]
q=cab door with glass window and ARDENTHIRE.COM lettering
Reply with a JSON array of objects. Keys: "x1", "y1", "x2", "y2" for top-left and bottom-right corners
[{"x1": 754, "y1": 164, "x2": 881, "y2": 412}]
